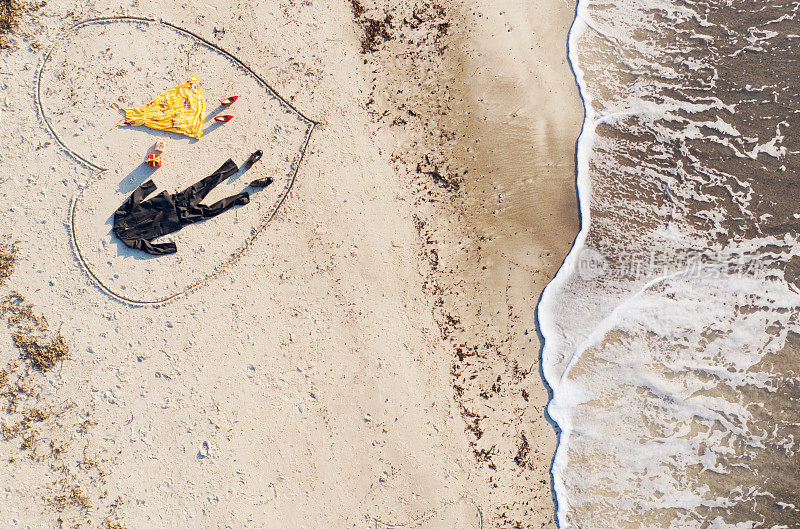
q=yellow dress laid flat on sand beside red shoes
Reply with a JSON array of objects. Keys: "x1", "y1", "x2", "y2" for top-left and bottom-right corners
[{"x1": 119, "y1": 77, "x2": 206, "y2": 140}]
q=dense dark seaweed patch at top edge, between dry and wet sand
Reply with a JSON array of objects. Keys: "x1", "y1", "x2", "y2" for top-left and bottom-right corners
[{"x1": 350, "y1": 0, "x2": 465, "y2": 190}]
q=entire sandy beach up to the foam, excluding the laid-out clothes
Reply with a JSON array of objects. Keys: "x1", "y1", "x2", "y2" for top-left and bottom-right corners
[{"x1": 0, "y1": 0, "x2": 581, "y2": 529}]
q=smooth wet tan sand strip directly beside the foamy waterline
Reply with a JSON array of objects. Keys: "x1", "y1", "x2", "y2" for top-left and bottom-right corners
[{"x1": 438, "y1": 2, "x2": 583, "y2": 527}]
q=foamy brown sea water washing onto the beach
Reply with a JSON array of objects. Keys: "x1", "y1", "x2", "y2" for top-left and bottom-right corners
[{"x1": 539, "y1": 0, "x2": 800, "y2": 529}]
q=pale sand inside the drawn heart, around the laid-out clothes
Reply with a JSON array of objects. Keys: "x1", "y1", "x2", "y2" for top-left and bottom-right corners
[{"x1": 37, "y1": 17, "x2": 314, "y2": 304}]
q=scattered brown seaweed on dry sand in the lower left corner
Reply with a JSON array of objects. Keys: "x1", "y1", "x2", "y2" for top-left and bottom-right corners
[{"x1": 0, "y1": 245, "x2": 125, "y2": 529}]
